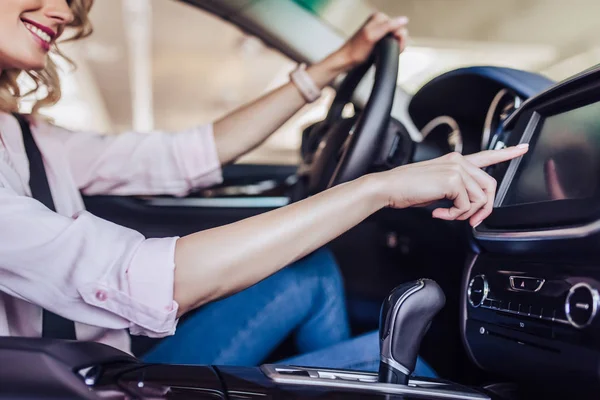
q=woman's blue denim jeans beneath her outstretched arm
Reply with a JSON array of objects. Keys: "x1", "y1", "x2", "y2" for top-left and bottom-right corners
[{"x1": 142, "y1": 250, "x2": 435, "y2": 376}]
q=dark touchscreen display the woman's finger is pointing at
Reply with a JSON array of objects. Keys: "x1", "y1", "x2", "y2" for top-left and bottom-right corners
[{"x1": 502, "y1": 102, "x2": 600, "y2": 206}]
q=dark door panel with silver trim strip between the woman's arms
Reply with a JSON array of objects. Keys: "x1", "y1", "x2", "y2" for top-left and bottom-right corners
[{"x1": 84, "y1": 165, "x2": 296, "y2": 237}]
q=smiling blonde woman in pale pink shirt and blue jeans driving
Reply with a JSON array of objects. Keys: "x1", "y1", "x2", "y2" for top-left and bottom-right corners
[{"x1": 0, "y1": 0, "x2": 526, "y2": 375}]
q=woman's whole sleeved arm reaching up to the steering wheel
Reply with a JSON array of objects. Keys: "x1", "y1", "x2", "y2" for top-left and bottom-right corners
[{"x1": 44, "y1": 14, "x2": 407, "y2": 196}]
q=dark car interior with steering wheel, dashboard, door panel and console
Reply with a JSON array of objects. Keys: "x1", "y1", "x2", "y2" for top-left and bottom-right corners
[{"x1": 0, "y1": 0, "x2": 600, "y2": 400}]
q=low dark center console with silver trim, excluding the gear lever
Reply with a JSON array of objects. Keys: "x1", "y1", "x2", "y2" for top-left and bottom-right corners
[{"x1": 0, "y1": 338, "x2": 490, "y2": 400}]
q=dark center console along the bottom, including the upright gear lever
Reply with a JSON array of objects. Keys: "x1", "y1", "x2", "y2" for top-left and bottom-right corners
[{"x1": 0, "y1": 279, "x2": 494, "y2": 400}]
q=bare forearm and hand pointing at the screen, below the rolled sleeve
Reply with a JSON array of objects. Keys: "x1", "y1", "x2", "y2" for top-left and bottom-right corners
[{"x1": 174, "y1": 147, "x2": 527, "y2": 314}]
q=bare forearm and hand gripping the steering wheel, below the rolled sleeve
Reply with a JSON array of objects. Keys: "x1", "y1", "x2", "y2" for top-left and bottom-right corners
[{"x1": 214, "y1": 13, "x2": 408, "y2": 164}]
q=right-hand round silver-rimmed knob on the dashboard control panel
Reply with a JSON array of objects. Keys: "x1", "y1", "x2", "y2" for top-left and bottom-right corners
[{"x1": 565, "y1": 282, "x2": 600, "y2": 329}]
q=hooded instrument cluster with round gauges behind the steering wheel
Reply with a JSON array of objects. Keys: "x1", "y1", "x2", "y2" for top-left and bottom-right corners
[{"x1": 408, "y1": 67, "x2": 553, "y2": 154}]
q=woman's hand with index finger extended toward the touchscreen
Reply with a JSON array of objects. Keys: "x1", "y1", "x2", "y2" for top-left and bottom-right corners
[{"x1": 379, "y1": 145, "x2": 528, "y2": 226}]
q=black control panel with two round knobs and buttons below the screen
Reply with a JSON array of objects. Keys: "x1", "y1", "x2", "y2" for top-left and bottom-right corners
[{"x1": 463, "y1": 254, "x2": 600, "y2": 390}]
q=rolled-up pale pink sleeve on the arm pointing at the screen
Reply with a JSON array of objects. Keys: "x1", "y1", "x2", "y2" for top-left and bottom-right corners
[{"x1": 0, "y1": 183, "x2": 178, "y2": 337}]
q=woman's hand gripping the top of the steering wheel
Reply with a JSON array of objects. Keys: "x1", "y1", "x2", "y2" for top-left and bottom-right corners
[{"x1": 336, "y1": 12, "x2": 408, "y2": 71}]
